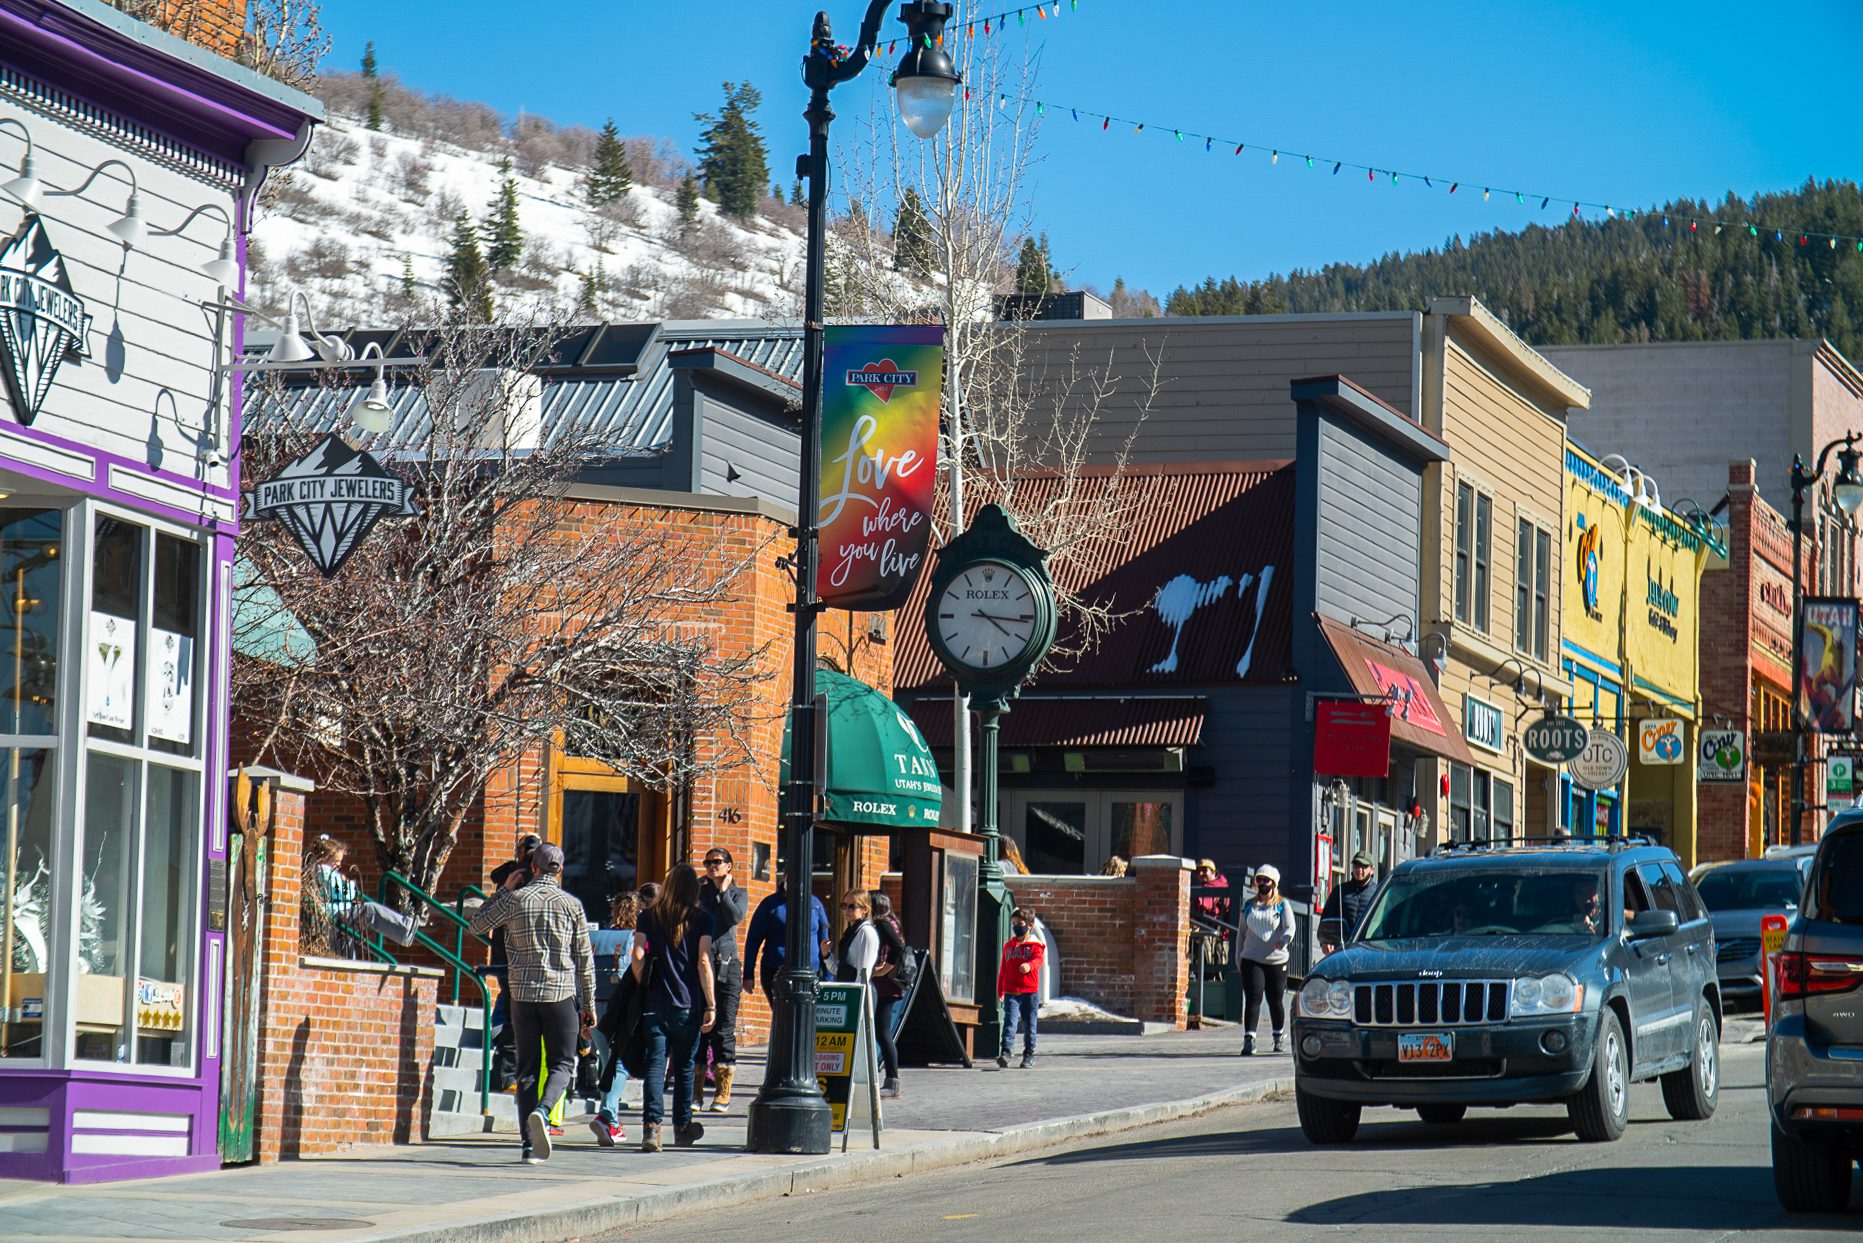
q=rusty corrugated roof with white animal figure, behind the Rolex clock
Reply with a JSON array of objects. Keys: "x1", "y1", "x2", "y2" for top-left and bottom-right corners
[{"x1": 894, "y1": 462, "x2": 1293, "y2": 696}]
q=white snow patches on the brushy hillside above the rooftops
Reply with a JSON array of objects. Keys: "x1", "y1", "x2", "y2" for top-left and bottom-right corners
[{"x1": 250, "y1": 114, "x2": 803, "y2": 330}]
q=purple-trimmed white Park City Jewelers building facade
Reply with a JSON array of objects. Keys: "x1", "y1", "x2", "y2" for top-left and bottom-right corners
[{"x1": 0, "y1": 0, "x2": 322, "y2": 1182}]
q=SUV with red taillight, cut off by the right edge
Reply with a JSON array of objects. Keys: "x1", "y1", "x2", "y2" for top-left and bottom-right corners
[{"x1": 1766, "y1": 813, "x2": 1863, "y2": 1213}]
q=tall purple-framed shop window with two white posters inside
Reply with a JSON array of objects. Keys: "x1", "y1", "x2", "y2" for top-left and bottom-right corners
[{"x1": 71, "y1": 514, "x2": 203, "y2": 1068}]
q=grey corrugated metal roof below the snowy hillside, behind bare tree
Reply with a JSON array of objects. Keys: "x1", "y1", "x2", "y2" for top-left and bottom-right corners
[{"x1": 246, "y1": 321, "x2": 803, "y2": 457}]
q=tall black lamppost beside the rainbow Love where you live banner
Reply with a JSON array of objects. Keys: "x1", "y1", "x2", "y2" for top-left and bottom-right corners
[{"x1": 745, "y1": 0, "x2": 958, "y2": 1154}]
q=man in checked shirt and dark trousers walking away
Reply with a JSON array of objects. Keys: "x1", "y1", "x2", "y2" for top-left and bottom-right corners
[{"x1": 469, "y1": 842, "x2": 594, "y2": 1165}]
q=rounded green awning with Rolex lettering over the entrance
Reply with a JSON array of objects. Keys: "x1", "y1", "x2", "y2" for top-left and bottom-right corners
[{"x1": 782, "y1": 669, "x2": 943, "y2": 829}]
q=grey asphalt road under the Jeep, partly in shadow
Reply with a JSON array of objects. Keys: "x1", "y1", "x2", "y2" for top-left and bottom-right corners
[{"x1": 609, "y1": 1044, "x2": 1863, "y2": 1243}]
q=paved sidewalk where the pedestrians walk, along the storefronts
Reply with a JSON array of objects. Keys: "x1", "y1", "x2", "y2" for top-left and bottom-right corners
[{"x1": 0, "y1": 1029, "x2": 1293, "y2": 1243}]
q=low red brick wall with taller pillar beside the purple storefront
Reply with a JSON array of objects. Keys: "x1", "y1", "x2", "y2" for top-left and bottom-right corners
[{"x1": 255, "y1": 771, "x2": 438, "y2": 1161}]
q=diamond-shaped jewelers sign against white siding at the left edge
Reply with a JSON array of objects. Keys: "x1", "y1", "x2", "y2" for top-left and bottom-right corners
[{"x1": 0, "y1": 212, "x2": 91, "y2": 423}]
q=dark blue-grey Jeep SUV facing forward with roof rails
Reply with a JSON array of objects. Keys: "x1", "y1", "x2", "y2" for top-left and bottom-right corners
[{"x1": 1293, "y1": 839, "x2": 1721, "y2": 1144}]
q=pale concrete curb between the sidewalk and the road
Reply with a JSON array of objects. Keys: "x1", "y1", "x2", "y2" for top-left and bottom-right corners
[{"x1": 358, "y1": 1075, "x2": 1293, "y2": 1243}]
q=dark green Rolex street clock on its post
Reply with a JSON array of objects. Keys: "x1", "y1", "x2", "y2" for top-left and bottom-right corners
[{"x1": 926, "y1": 505, "x2": 1054, "y2": 1053}]
